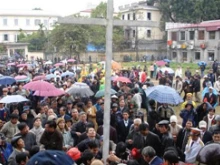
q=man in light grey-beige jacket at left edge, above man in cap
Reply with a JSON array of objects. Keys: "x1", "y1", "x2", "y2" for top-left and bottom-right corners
[{"x1": 0, "y1": 114, "x2": 19, "y2": 143}]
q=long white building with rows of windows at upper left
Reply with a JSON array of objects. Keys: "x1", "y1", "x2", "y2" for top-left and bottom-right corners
[{"x1": 0, "y1": 10, "x2": 59, "y2": 43}]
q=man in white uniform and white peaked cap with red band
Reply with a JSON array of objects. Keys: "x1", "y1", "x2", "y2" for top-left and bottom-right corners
[{"x1": 184, "y1": 128, "x2": 204, "y2": 163}]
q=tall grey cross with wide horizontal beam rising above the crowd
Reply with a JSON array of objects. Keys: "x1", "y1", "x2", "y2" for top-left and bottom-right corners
[{"x1": 58, "y1": 0, "x2": 158, "y2": 164}]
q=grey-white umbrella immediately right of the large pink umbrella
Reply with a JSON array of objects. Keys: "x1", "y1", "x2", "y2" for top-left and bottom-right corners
[{"x1": 66, "y1": 82, "x2": 94, "y2": 97}]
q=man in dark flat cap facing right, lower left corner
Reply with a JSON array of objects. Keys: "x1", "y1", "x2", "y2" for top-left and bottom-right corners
[{"x1": 8, "y1": 136, "x2": 27, "y2": 165}]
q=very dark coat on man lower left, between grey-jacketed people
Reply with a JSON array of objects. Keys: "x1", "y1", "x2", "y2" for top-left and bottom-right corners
[{"x1": 40, "y1": 130, "x2": 63, "y2": 150}]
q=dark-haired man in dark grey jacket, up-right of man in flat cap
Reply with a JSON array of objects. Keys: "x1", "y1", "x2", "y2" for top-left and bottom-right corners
[{"x1": 14, "y1": 122, "x2": 37, "y2": 151}]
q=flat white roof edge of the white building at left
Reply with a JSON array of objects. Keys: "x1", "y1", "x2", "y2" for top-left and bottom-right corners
[{"x1": 0, "y1": 10, "x2": 60, "y2": 17}]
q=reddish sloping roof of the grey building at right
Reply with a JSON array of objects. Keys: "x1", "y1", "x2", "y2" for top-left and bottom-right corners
[{"x1": 170, "y1": 20, "x2": 220, "y2": 31}]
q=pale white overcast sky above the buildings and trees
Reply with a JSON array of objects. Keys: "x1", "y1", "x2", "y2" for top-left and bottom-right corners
[{"x1": 0, "y1": 0, "x2": 139, "y2": 16}]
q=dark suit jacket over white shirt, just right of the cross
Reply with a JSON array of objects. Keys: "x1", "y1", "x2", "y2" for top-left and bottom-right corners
[{"x1": 117, "y1": 120, "x2": 133, "y2": 142}]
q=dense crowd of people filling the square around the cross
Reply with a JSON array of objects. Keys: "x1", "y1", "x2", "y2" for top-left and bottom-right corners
[{"x1": 0, "y1": 58, "x2": 220, "y2": 165}]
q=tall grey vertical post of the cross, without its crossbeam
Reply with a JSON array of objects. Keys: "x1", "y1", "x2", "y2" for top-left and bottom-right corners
[{"x1": 103, "y1": 0, "x2": 114, "y2": 165}]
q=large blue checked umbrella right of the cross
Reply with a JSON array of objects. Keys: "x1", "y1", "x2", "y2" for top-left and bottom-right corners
[{"x1": 145, "y1": 85, "x2": 183, "y2": 105}]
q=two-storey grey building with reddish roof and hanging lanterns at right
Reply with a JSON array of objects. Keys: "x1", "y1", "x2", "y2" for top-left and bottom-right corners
[{"x1": 166, "y1": 20, "x2": 220, "y2": 62}]
